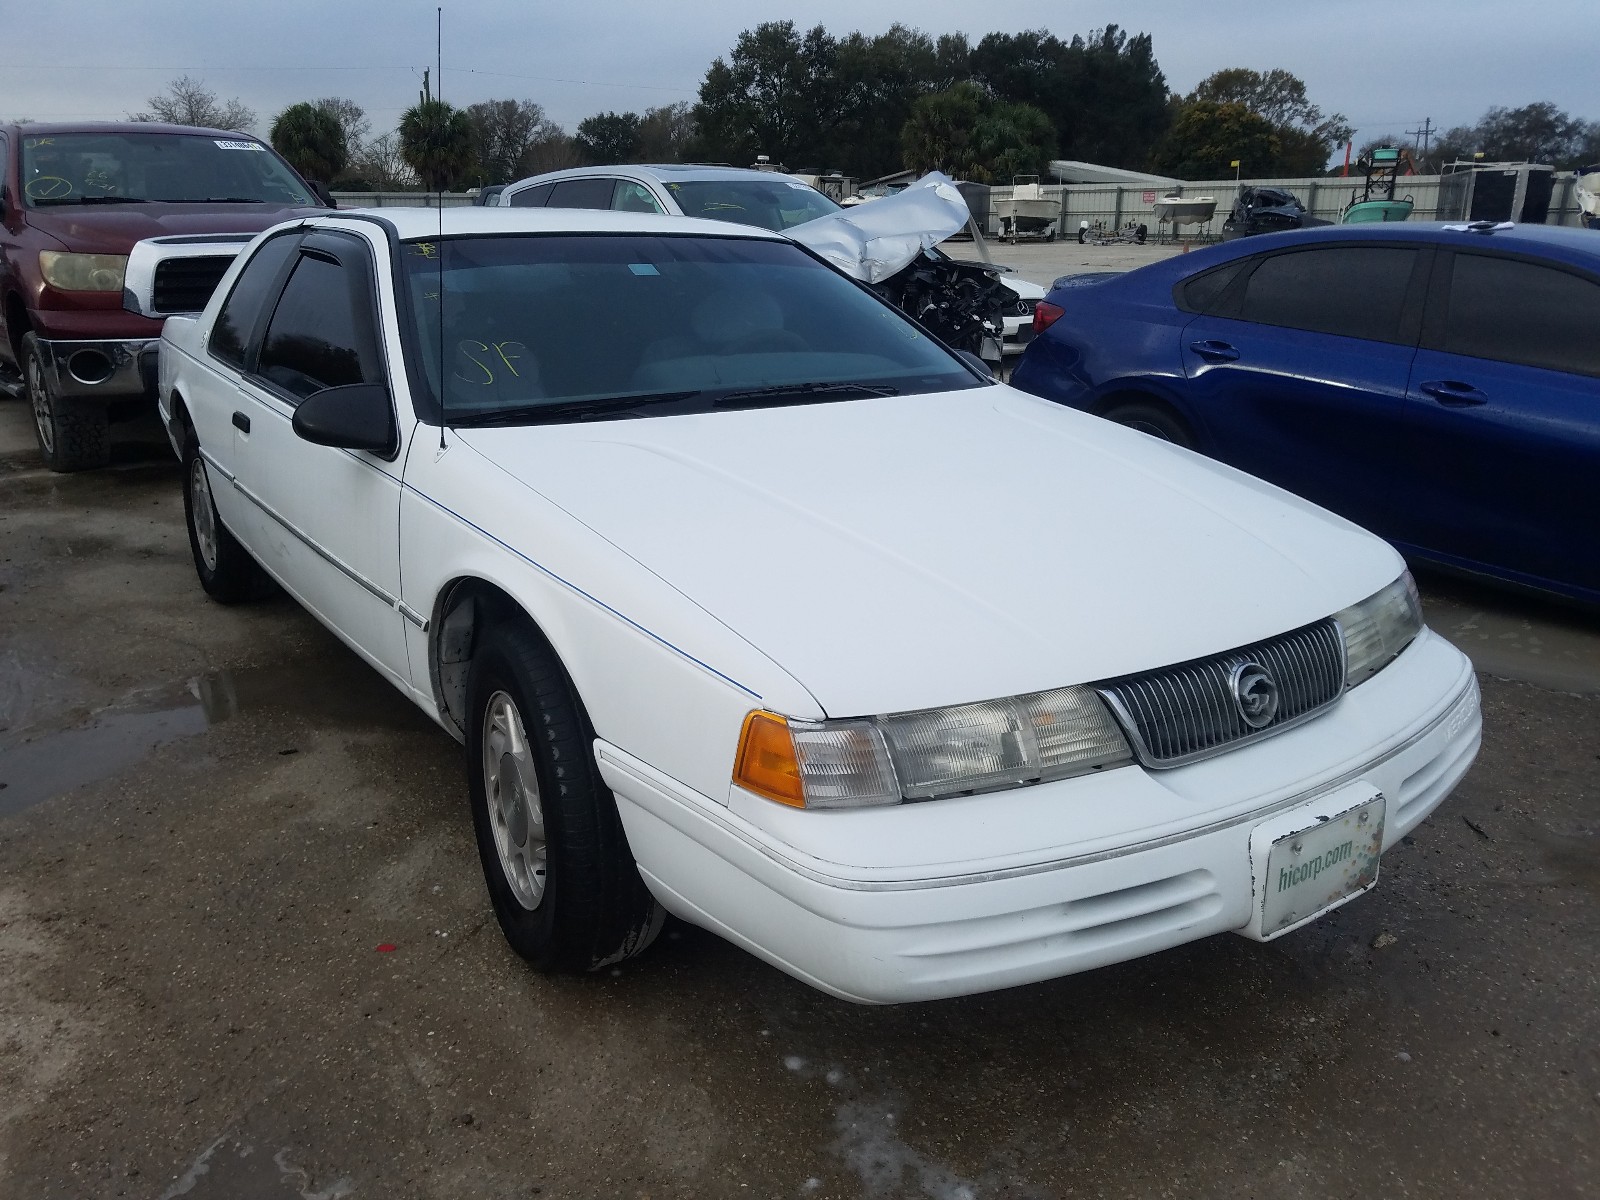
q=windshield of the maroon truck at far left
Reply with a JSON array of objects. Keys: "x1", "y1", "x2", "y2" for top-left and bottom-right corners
[{"x1": 21, "y1": 133, "x2": 317, "y2": 208}]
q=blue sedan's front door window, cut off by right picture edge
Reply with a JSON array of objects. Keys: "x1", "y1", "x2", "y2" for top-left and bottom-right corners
[{"x1": 1440, "y1": 253, "x2": 1600, "y2": 376}]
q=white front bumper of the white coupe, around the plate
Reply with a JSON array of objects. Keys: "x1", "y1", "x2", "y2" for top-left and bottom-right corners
[{"x1": 597, "y1": 632, "x2": 1482, "y2": 1003}]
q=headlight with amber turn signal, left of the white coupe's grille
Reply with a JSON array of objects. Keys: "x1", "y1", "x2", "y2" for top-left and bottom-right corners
[{"x1": 733, "y1": 688, "x2": 1133, "y2": 808}]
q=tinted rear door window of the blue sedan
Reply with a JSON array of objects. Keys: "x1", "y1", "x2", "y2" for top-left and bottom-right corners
[{"x1": 1238, "y1": 246, "x2": 1416, "y2": 342}]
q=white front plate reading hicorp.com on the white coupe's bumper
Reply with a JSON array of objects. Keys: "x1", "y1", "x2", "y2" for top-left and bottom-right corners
[{"x1": 1251, "y1": 789, "x2": 1386, "y2": 941}]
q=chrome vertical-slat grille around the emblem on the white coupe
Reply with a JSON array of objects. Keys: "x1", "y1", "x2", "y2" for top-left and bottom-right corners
[{"x1": 1096, "y1": 618, "x2": 1344, "y2": 766}]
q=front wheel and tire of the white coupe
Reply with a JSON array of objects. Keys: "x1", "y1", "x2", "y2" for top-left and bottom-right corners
[{"x1": 467, "y1": 622, "x2": 666, "y2": 971}]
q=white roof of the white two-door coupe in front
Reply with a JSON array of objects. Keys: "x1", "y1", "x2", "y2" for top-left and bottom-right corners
[{"x1": 323, "y1": 205, "x2": 786, "y2": 242}]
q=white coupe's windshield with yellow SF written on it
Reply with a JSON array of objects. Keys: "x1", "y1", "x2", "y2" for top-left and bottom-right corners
[{"x1": 400, "y1": 234, "x2": 979, "y2": 424}]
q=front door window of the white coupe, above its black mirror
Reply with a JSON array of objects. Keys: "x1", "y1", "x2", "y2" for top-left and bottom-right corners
[{"x1": 256, "y1": 253, "x2": 376, "y2": 400}]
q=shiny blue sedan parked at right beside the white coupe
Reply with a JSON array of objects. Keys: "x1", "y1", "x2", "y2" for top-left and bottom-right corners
[{"x1": 1011, "y1": 222, "x2": 1600, "y2": 603}]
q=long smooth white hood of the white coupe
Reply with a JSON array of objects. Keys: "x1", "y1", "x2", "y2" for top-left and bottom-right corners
[{"x1": 458, "y1": 386, "x2": 1402, "y2": 717}]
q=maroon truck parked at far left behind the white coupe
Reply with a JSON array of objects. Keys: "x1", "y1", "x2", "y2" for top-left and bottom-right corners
[{"x1": 0, "y1": 123, "x2": 326, "y2": 470}]
